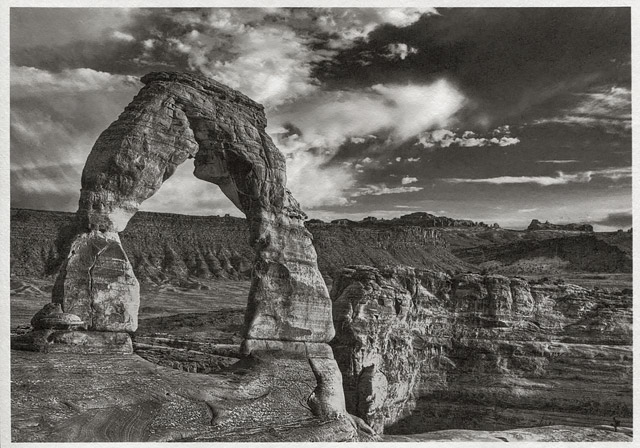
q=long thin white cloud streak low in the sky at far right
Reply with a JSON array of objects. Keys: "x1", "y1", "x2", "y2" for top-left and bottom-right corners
[{"x1": 443, "y1": 167, "x2": 631, "y2": 187}]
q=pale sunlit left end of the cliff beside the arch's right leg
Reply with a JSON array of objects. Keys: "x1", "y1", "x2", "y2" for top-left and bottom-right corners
[{"x1": 331, "y1": 266, "x2": 451, "y2": 433}]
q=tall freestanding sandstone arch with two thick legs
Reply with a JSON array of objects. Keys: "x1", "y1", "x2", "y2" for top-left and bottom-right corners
[{"x1": 48, "y1": 72, "x2": 334, "y2": 344}]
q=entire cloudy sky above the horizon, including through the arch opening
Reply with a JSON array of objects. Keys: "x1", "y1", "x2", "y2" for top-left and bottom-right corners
[{"x1": 10, "y1": 8, "x2": 632, "y2": 231}]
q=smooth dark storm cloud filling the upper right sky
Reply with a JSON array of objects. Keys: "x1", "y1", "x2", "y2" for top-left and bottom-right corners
[{"x1": 316, "y1": 8, "x2": 631, "y2": 126}]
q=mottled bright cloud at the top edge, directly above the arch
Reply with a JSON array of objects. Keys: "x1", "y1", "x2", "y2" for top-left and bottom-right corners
[{"x1": 112, "y1": 8, "x2": 435, "y2": 108}]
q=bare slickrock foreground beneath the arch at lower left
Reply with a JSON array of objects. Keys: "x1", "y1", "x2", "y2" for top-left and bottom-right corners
[{"x1": 11, "y1": 351, "x2": 370, "y2": 443}]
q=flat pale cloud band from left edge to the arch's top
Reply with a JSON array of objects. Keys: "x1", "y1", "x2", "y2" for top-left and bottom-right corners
[{"x1": 10, "y1": 65, "x2": 142, "y2": 98}]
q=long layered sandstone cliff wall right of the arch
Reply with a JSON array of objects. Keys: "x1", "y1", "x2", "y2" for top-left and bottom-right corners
[{"x1": 332, "y1": 266, "x2": 632, "y2": 434}]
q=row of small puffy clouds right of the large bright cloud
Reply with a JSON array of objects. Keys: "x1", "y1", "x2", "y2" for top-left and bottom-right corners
[{"x1": 416, "y1": 125, "x2": 520, "y2": 148}]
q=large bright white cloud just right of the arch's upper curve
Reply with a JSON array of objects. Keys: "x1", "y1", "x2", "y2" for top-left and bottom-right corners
[{"x1": 270, "y1": 80, "x2": 465, "y2": 207}]
